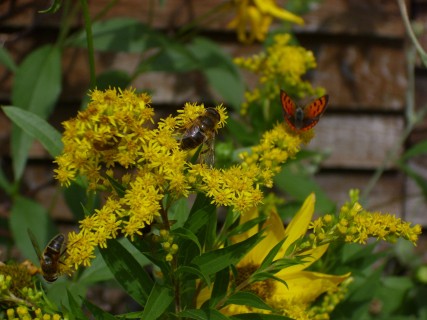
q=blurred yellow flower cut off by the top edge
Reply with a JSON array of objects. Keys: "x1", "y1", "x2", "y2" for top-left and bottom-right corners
[{"x1": 228, "y1": 0, "x2": 304, "y2": 43}]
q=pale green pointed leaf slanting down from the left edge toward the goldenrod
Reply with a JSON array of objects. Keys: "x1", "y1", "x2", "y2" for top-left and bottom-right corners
[{"x1": 3, "y1": 107, "x2": 64, "y2": 157}]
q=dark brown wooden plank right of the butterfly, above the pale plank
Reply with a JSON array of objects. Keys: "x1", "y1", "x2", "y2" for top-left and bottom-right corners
[{"x1": 313, "y1": 43, "x2": 407, "y2": 111}]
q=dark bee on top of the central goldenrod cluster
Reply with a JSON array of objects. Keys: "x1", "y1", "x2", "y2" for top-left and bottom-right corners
[{"x1": 180, "y1": 108, "x2": 221, "y2": 166}]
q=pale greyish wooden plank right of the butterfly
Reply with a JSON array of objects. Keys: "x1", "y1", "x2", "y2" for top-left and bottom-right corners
[{"x1": 308, "y1": 113, "x2": 404, "y2": 169}]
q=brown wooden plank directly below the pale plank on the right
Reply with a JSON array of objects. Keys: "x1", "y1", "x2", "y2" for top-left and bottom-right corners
[{"x1": 316, "y1": 171, "x2": 405, "y2": 217}]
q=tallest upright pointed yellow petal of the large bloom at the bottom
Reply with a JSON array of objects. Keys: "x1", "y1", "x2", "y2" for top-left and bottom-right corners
[{"x1": 282, "y1": 193, "x2": 316, "y2": 255}]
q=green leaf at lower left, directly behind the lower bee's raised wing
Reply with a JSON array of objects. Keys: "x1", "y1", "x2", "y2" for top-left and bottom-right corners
[{"x1": 9, "y1": 196, "x2": 58, "y2": 262}]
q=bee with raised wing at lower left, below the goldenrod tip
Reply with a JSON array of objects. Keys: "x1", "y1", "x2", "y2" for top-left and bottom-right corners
[{"x1": 28, "y1": 230, "x2": 66, "y2": 282}]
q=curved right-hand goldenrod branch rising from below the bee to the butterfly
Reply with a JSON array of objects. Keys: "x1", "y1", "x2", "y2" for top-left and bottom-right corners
[{"x1": 188, "y1": 123, "x2": 313, "y2": 213}]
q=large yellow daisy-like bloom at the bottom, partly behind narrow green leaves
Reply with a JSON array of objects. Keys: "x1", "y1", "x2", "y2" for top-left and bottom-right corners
[{"x1": 197, "y1": 194, "x2": 350, "y2": 319}]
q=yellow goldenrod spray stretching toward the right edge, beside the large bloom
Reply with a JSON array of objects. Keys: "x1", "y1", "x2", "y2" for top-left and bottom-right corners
[{"x1": 310, "y1": 190, "x2": 421, "y2": 245}]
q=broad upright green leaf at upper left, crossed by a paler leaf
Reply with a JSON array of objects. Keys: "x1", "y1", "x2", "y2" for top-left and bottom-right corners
[{"x1": 11, "y1": 45, "x2": 61, "y2": 180}]
